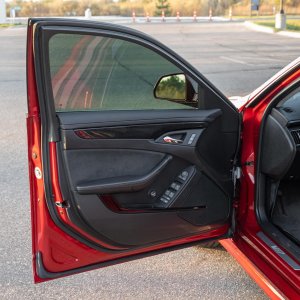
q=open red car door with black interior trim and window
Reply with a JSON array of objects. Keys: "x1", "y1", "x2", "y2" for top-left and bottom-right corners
[{"x1": 27, "y1": 19, "x2": 240, "y2": 282}]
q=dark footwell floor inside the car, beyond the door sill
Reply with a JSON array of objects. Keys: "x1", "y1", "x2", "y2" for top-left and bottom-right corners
[{"x1": 272, "y1": 181, "x2": 300, "y2": 245}]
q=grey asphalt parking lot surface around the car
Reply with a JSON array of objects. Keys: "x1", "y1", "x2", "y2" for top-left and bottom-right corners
[{"x1": 0, "y1": 23, "x2": 300, "y2": 299}]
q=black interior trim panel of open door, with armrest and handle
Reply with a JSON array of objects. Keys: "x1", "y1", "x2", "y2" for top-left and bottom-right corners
[{"x1": 58, "y1": 110, "x2": 230, "y2": 247}]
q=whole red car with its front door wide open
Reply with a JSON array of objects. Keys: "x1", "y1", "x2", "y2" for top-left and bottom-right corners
[{"x1": 27, "y1": 19, "x2": 300, "y2": 299}]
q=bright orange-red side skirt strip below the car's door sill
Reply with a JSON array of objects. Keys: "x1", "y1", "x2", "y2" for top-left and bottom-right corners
[{"x1": 219, "y1": 239, "x2": 286, "y2": 299}]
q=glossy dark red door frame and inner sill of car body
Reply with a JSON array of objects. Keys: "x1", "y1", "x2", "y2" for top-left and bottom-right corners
[{"x1": 233, "y1": 64, "x2": 300, "y2": 299}]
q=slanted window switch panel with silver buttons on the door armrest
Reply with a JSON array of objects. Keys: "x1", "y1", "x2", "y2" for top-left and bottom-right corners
[{"x1": 156, "y1": 166, "x2": 195, "y2": 208}]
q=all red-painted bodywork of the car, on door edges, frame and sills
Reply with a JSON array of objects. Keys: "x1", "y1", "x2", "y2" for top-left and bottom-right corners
[{"x1": 27, "y1": 19, "x2": 300, "y2": 299}]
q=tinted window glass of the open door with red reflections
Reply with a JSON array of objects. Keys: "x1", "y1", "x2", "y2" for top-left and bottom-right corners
[{"x1": 49, "y1": 34, "x2": 195, "y2": 112}]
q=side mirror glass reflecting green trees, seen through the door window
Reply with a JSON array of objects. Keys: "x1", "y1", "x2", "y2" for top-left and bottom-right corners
[{"x1": 154, "y1": 74, "x2": 187, "y2": 101}]
